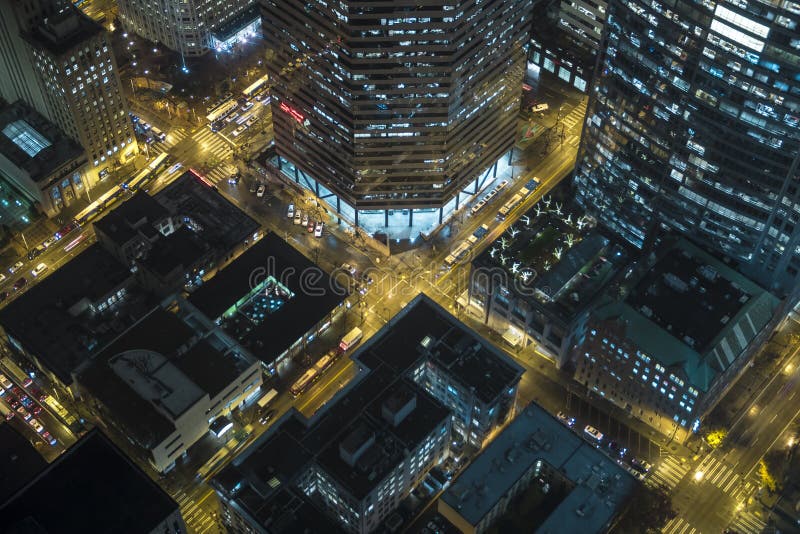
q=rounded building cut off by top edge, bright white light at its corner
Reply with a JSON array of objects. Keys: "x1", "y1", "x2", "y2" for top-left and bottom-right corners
[{"x1": 119, "y1": 0, "x2": 259, "y2": 58}]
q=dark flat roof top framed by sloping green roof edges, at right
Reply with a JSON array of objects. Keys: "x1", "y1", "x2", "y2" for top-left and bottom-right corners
[{"x1": 625, "y1": 242, "x2": 763, "y2": 352}]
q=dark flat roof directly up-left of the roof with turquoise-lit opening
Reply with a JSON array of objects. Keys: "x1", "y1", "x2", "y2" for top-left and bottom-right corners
[{"x1": 153, "y1": 171, "x2": 261, "y2": 252}]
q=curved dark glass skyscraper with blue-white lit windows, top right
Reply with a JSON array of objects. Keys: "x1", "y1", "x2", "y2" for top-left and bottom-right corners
[{"x1": 575, "y1": 0, "x2": 800, "y2": 292}]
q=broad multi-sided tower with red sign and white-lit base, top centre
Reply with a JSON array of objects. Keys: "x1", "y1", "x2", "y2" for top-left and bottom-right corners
[{"x1": 262, "y1": 0, "x2": 531, "y2": 232}]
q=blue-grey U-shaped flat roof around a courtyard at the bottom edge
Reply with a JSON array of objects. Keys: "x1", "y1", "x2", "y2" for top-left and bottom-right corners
[{"x1": 441, "y1": 403, "x2": 636, "y2": 534}]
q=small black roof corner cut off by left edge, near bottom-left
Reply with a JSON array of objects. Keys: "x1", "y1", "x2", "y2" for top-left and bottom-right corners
[{"x1": 0, "y1": 421, "x2": 47, "y2": 504}]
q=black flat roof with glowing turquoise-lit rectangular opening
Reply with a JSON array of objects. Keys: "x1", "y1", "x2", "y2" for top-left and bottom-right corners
[{"x1": 189, "y1": 232, "x2": 346, "y2": 363}]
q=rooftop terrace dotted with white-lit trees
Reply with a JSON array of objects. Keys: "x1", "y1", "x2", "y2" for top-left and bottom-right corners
[{"x1": 471, "y1": 197, "x2": 627, "y2": 323}]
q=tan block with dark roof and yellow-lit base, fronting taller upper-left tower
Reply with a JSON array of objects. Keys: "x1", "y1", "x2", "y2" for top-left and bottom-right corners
[{"x1": 26, "y1": 7, "x2": 137, "y2": 172}]
